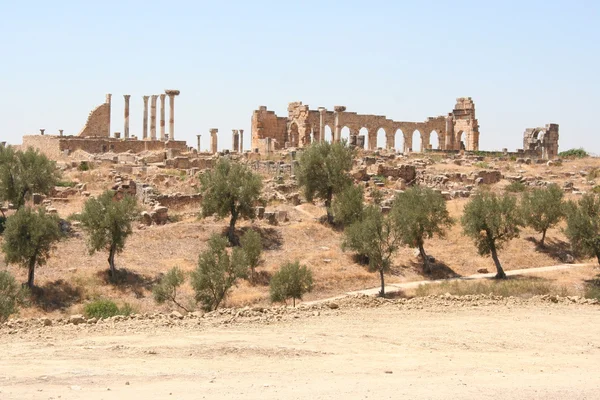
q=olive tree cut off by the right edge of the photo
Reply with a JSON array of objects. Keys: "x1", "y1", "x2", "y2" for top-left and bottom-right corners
[{"x1": 565, "y1": 193, "x2": 600, "y2": 264}]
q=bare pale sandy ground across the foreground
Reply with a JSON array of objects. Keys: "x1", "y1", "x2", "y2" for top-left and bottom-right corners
[{"x1": 0, "y1": 302, "x2": 600, "y2": 400}]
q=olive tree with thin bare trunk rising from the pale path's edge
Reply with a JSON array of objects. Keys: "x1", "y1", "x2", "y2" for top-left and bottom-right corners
[{"x1": 342, "y1": 206, "x2": 402, "y2": 297}]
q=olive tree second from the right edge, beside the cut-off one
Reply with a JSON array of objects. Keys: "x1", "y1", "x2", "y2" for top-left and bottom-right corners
[{"x1": 521, "y1": 184, "x2": 564, "y2": 247}]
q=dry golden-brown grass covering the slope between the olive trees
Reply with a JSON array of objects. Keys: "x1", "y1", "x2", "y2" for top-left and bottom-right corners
[{"x1": 0, "y1": 152, "x2": 600, "y2": 316}]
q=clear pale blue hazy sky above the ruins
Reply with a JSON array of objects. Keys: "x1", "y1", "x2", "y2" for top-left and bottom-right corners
[{"x1": 0, "y1": 0, "x2": 600, "y2": 153}]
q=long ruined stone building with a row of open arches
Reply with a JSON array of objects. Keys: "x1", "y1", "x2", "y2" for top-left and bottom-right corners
[{"x1": 252, "y1": 97, "x2": 479, "y2": 153}]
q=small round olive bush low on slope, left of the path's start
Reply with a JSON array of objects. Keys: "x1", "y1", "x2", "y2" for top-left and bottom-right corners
[{"x1": 269, "y1": 261, "x2": 313, "y2": 307}]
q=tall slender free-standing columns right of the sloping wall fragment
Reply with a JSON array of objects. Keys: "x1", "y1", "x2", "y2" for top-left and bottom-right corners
[{"x1": 123, "y1": 90, "x2": 180, "y2": 141}]
